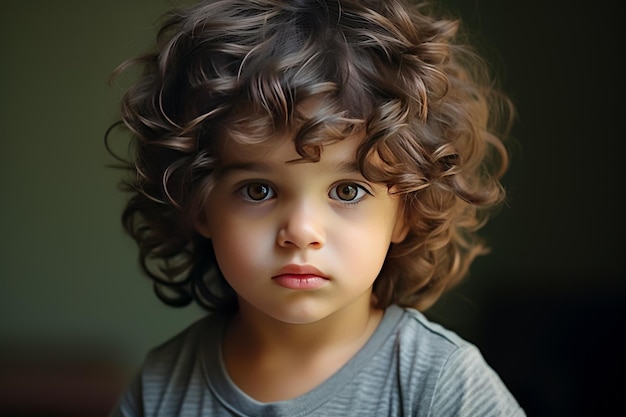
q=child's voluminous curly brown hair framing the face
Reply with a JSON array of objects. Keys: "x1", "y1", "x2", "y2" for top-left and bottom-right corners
[{"x1": 107, "y1": 0, "x2": 514, "y2": 311}]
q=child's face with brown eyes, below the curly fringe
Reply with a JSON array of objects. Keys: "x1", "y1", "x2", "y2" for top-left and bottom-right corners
[{"x1": 198, "y1": 132, "x2": 406, "y2": 324}]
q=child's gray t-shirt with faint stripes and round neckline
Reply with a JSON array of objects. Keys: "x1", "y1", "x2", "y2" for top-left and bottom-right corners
[{"x1": 111, "y1": 306, "x2": 525, "y2": 417}]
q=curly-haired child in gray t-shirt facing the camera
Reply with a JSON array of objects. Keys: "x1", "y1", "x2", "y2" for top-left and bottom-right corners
[{"x1": 106, "y1": 0, "x2": 524, "y2": 417}]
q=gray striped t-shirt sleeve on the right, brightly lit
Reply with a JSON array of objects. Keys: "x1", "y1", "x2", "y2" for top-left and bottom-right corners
[{"x1": 430, "y1": 345, "x2": 526, "y2": 417}]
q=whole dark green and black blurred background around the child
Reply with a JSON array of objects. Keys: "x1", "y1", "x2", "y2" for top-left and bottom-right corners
[{"x1": 0, "y1": 0, "x2": 626, "y2": 417}]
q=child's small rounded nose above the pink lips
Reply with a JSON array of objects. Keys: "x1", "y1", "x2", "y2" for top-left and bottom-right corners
[{"x1": 277, "y1": 201, "x2": 326, "y2": 249}]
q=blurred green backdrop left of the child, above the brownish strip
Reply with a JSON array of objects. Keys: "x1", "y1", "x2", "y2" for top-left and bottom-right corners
[{"x1": 0, "y1": 0, "x2": 205, "y2": 367}]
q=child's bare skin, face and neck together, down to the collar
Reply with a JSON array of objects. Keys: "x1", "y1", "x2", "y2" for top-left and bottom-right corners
[{"x1": 197, "y1": 132, "x2": 407, "y2": 401}]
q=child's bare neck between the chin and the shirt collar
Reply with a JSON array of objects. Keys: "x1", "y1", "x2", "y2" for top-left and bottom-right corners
[{"x1": 222, "y1": 290, "x2": 383, "y2": 402}]
